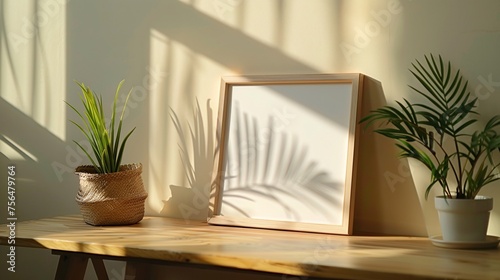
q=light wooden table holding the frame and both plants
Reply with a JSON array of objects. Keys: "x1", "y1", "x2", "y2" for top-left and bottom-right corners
[{"x1": 0, "y1": 215, "x2": 500, "y2": 280}]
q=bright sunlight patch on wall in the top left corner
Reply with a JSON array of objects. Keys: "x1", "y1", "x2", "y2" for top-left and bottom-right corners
[{"x1": 0, "y1": 0, "x2": 66, "y2": 140}]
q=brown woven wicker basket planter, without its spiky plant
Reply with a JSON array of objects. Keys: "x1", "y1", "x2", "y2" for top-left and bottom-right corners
[{"x1": 76, "y1": 164, "x2": 148, "y2": 226}]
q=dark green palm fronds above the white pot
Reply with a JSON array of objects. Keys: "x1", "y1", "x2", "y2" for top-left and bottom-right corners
[{"x1": 361, "y1": 54, "x2": 500, "y2": 244}]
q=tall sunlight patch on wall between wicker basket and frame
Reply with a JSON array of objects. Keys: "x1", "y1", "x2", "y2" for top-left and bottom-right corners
[{"x1": 148, "y1": 29, "x2": 227, "y2": 219}]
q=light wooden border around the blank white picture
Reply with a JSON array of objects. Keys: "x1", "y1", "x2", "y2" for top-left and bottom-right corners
[{"x1": 208, "y1": 73, "x2": 363, "y2": 235}]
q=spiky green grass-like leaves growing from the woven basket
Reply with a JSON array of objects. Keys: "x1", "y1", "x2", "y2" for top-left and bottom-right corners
[{"x1": 66, "y1": 81, "x2": 135, "y2": 173}]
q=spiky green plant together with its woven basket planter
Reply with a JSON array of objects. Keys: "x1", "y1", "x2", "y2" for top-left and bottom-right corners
[{"x1": 66, "y1": 81, "x2": 147, "y2": 225}]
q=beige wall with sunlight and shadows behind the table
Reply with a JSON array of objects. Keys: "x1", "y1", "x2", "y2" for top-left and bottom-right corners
[{"x1": 0, "y1": 0, "x2": 500, "y2": 279}]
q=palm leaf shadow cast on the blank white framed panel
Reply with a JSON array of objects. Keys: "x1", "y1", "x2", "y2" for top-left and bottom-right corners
[{"x1": 222, "y1": 103, "x2": 343, "y2": 221}]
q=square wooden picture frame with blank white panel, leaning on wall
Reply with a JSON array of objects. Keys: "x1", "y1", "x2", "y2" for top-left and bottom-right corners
[{"x1": 208, "y1": 73, "x2": 363, "y2": 235}]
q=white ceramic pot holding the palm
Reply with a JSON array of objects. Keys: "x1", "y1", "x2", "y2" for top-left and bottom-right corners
[{"x1": 434, "y1": 195, "x2": 493, "y2": 242}]
